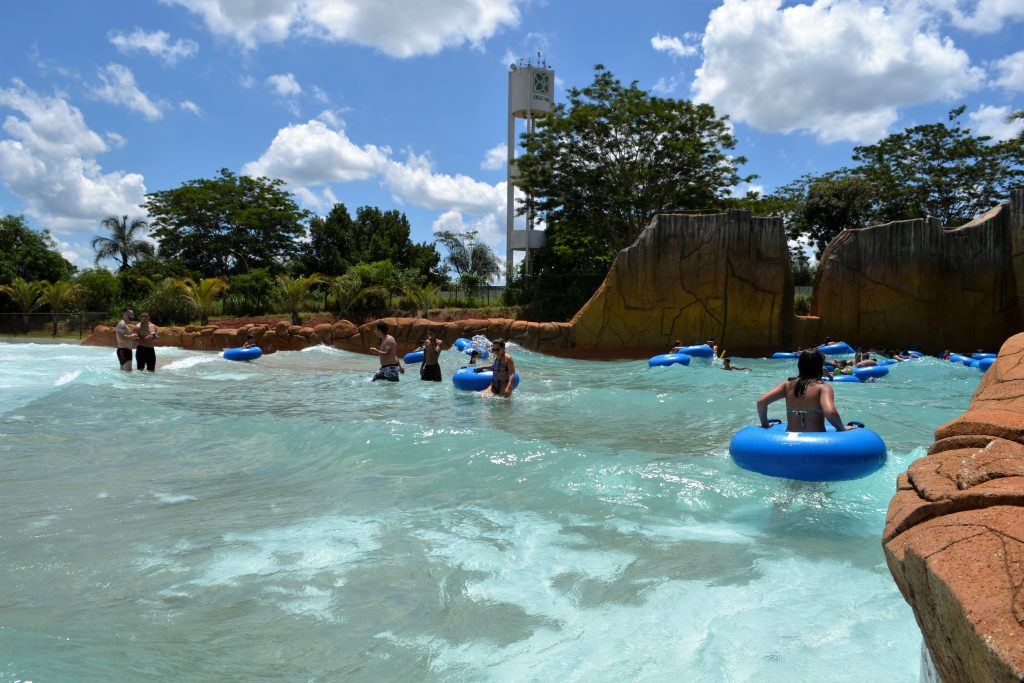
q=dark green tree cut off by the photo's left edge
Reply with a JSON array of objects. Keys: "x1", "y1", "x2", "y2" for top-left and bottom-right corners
[{"x1": 0, "y1": 215, "x2": 75, "y2": 284}]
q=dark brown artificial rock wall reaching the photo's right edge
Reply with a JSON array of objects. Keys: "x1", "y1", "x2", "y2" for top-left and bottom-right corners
[{"x1": 796, "y1": 189, "x2": 1024, "y2": 353}]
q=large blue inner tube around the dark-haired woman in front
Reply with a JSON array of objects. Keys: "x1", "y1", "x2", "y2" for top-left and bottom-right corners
[{"x1": 729, "y1": 424, "x2": 887, "y2": 481}]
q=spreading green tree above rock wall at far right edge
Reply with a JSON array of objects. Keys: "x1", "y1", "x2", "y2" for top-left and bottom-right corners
[{"x1": 853, "y1": 106, "x2": 1024, "y2": 226}]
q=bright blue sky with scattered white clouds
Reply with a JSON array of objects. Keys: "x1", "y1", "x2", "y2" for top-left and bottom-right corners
[{"x1": 0, "y1": 0, "x2": 1024, "y2": 266}]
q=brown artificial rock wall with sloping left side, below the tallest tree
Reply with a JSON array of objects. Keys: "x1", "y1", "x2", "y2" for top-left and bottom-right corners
[{"x1": 571, "y1": 210, "x2": 793, "y2": 356}]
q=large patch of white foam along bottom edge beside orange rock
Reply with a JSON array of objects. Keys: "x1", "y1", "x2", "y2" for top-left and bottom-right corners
[{"x1": 395, "y1": 512, "x2": 918, "y2": 683}]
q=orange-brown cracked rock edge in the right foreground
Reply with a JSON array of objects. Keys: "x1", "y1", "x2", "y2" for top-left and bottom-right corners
[{"x1": 883, "y1": 334, "x2": 1024, "y2": 683}]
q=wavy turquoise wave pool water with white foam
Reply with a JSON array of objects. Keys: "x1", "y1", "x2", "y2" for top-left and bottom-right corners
[{"x1": 0, "y1": 344, "x2": 979, "y2": 681}]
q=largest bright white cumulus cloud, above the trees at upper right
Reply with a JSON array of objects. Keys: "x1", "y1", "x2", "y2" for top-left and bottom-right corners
[{"x1": 692, "y1": 0, "x2": 984, "y2": 142}]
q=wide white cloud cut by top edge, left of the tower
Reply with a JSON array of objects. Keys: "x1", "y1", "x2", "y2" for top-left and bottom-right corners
[{"x1": 163, "y1": 0, "x2": 519, "y2": 57}]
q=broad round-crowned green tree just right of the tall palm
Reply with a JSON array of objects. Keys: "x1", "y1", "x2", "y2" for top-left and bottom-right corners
[{"x1": 145, "y1": 169, "x2": 309, "y2": 275}]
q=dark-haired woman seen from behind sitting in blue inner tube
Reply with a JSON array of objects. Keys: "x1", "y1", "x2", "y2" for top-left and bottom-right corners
[{"x1": 758, "y1": 349, "x2": 847, "y2": 432}]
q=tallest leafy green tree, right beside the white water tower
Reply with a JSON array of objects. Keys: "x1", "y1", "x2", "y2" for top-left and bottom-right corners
[{"x1": 517, "y1": 66, "x2": 751, "y2": 258}]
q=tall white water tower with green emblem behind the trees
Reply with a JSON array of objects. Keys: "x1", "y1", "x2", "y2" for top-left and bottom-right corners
[{"x1": 505, "y1": 54, "x2": 555, "y2": 280}]
